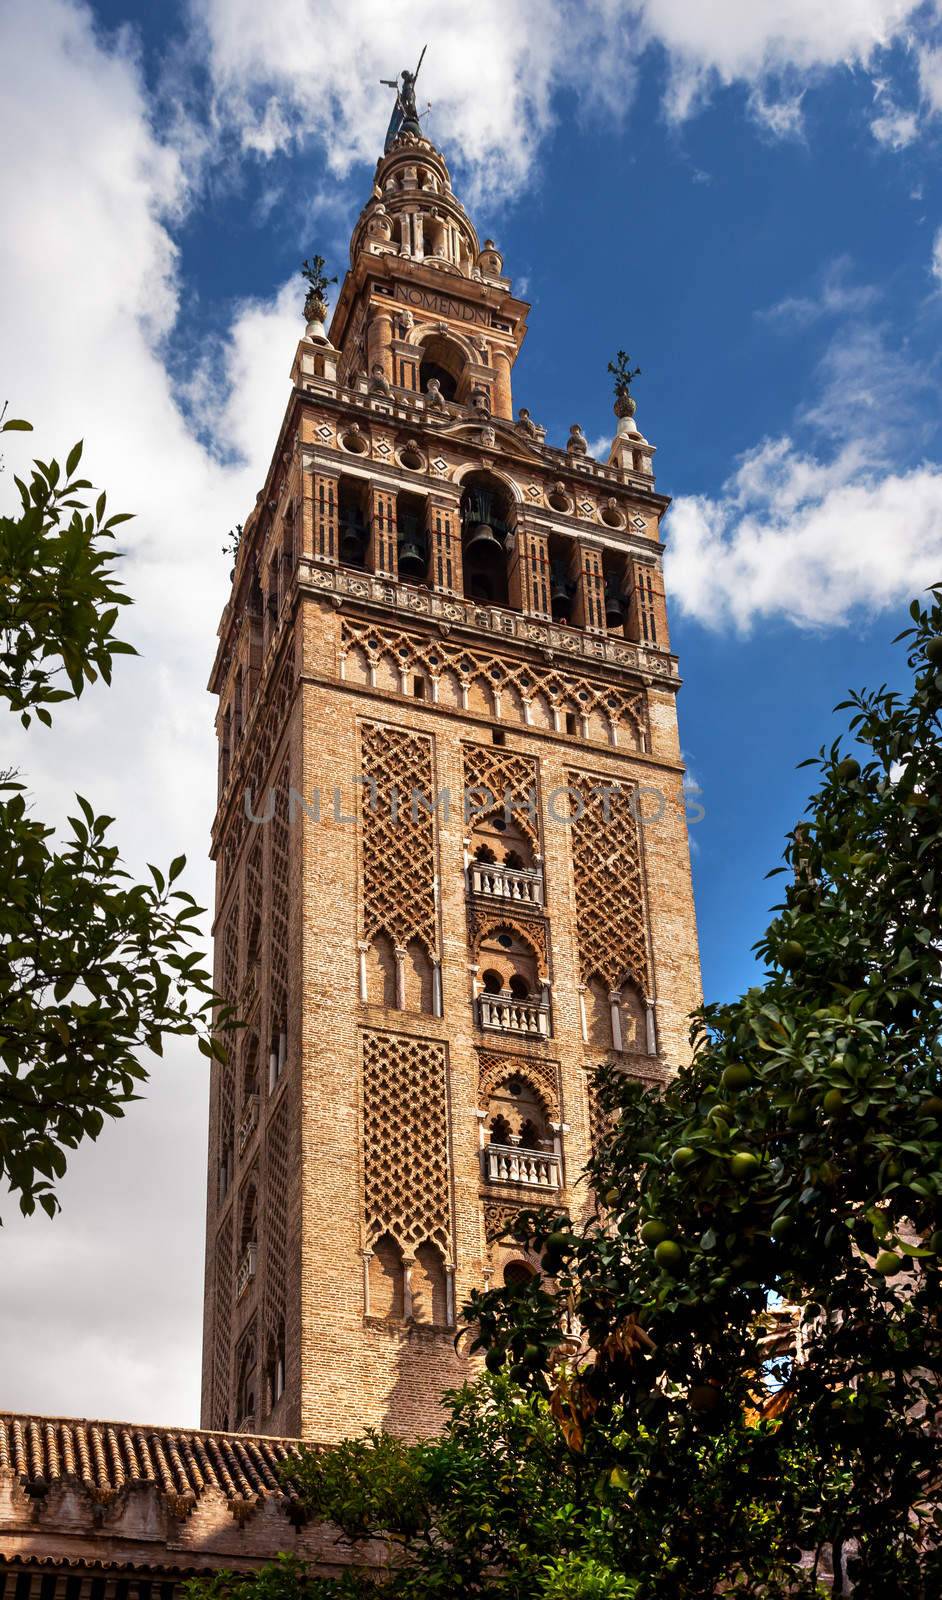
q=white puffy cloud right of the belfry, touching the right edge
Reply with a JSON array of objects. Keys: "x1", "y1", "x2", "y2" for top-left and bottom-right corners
[{"x1": 665, "y1": 438, "x2": 942, "y2": 634}]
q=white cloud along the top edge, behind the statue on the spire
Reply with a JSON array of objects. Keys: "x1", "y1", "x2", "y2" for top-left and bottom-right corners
[{"x1": 185, "y1": 0, "x2": 931, "y2": 200}]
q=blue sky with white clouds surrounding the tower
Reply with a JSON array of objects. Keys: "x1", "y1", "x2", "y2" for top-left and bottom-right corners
[{"x1": 0, "y1": 0, "x2": 942, "y2": 1421}]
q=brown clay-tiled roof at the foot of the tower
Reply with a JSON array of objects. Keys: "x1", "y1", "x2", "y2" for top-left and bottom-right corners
[{"x1": 0, "y1": 1411, "x2": 297, "y2": 1502}]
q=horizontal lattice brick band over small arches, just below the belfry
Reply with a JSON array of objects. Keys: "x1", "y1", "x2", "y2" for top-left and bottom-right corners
[{"x1": 341, "y1": 621, "x2": 646, "y2": 747}]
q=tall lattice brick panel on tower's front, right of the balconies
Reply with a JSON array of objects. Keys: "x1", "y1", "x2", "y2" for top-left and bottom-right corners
[{"x1": 568, "y1": 771, "x2": 651, "y2": 995}]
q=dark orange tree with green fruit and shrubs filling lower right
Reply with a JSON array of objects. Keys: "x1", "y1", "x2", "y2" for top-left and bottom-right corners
[{"x1": 187, "y1": 590, "x2": 942, "y2": 1600}]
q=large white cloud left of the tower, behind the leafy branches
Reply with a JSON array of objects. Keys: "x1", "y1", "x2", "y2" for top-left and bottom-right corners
[{"x1": 0, "y1": 0, "x2": 301, "y2": 1422}]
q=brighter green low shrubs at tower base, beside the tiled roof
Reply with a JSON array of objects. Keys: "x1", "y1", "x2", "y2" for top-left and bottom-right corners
[{"x1": 183, "y1": 1378, "x2": 637, "y2": 1600}]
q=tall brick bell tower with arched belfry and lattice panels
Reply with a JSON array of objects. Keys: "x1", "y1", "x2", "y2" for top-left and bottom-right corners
[{"x1": 203, "y1": 109, "x2": 699, "y2": 1440}]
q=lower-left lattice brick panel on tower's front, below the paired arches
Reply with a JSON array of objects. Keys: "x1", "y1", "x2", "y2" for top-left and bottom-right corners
[{"x1": 363, "y1": 1032, "x2": 451, "y2": 1259}]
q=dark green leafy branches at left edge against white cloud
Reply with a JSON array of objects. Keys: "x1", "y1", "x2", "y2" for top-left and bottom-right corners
[{"x1": 0, "y1": 421, "x2": 221, "y2": 1216}]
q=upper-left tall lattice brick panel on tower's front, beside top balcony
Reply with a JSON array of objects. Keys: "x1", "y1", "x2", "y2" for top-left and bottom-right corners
[{"x1": 360, "y1": 723, "x2": 438, "y2": 955}]
